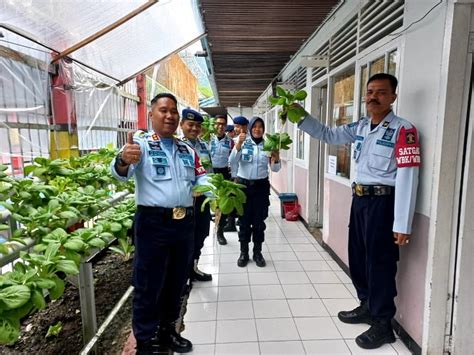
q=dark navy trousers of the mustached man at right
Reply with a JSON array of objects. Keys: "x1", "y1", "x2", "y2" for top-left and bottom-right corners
[{"x1": 349, "y1": 194, "x2": 399, "y2": 319}]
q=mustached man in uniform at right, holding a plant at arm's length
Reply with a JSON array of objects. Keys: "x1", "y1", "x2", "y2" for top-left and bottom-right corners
[{"x1": 299, "y1": 73, "x2": 421, "y2": 349}]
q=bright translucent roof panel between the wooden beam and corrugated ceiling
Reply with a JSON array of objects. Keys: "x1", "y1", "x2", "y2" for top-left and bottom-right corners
[{"x1": 71, "y1": 0, "x2": 204, "y2": 80}]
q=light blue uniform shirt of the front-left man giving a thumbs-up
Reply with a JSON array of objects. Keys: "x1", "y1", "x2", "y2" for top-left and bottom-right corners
[{"x1": 111, "y1": 131, "x2": 207, "y2": 208}]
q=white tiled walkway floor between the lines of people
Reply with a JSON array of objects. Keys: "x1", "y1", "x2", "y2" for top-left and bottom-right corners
[{"x1": 183, "y1": 195, "x2": 410, "y2": 355}]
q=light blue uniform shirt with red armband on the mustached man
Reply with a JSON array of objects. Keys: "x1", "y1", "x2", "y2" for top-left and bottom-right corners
[{"x1": 298, "y1": 112, "x2": 421, "y2": 234}]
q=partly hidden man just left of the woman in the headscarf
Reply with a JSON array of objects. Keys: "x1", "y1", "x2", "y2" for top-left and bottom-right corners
[{"x1": 211, "y1": 115, "x2": 234, "y2": 245}]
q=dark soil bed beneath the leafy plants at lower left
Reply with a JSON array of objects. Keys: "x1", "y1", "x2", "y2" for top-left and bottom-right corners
[{"x1": 0, "y1": 252, "x2": 132, "y2": 355}]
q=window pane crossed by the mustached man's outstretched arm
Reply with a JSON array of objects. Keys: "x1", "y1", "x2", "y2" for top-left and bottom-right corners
[{"x1": 328, "y1": 69, "x2": 355, "y2": 178}]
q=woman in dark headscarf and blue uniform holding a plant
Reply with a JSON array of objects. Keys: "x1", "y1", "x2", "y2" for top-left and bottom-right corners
[{"x1": 230, "y1": 117, "x2": 281, "y2": 267}]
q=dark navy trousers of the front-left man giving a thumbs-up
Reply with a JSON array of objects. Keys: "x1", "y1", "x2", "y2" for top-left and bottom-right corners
[{"x1": 132, "y1": 206, "x2": 194, "y2": 342}]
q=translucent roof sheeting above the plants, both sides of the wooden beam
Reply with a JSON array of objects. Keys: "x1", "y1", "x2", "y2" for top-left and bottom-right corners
[{"x1": 0, "y1": 0, "x2": 204, "y2": 81}]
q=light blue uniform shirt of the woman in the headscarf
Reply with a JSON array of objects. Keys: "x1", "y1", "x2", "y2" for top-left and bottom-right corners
[{"x1": 229, "y1": 136, "x2": 281, "y2": 180}]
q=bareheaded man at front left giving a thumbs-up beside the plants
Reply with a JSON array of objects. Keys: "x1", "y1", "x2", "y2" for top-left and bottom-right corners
[{"x1": 111, "y1": 93, "x2": 207, "y2": 354}]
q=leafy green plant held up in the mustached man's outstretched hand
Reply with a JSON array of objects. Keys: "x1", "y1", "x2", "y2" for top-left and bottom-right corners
[{"x1": 270, "y1": 86, "x2": 308, "y2": 124}]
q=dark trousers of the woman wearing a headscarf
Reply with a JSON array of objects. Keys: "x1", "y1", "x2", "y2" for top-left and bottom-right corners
[{"x1": 239, "y1": 179, "x2": 270, "y2": 251}]
